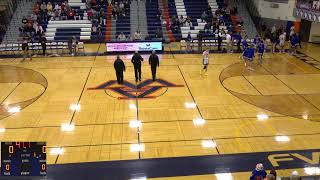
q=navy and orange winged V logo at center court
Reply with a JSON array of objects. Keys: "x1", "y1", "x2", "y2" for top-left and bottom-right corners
[{"x1": 88, "y1": 79, "x2": 183, "y2": 100}]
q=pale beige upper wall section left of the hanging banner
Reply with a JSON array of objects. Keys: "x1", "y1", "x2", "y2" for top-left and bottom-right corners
[{"x1": 254, "y1": 0, "x2": 296, "y2": 21}]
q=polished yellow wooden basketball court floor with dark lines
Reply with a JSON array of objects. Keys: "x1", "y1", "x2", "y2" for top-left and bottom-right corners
[{"x1": 0, "y1": 44, "x2": 320, "y2": 180}]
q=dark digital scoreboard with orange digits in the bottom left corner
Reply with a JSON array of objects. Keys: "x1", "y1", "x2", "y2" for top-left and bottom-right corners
[{"x1": 1, "y1": 142, "x2": 47, "y2": 176}]
